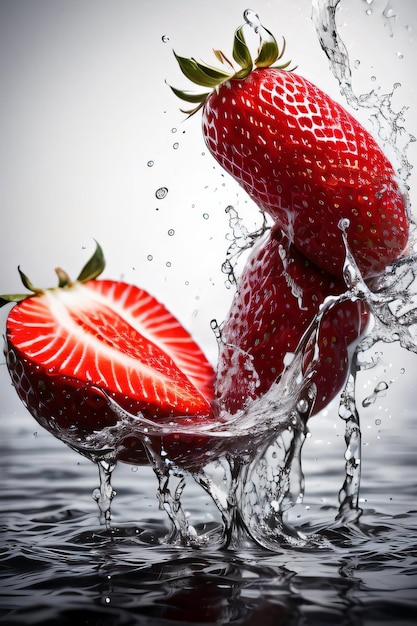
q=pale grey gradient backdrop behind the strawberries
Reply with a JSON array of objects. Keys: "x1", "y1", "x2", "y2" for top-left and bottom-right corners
[{"x1": 0, "y1": 0, "x2": 417, "y2": 415}]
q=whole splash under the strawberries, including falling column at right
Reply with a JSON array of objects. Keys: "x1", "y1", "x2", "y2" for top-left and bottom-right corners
[{"x1": 54, "y1": 213, "x2": 417, "y2": 550}]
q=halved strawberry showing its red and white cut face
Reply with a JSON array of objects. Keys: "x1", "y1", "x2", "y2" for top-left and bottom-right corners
[{"x1": 1, "y1": 245, "x2": 214, "y2": 462}]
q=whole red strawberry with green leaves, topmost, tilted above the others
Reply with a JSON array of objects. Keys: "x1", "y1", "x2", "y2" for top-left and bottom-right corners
[{"x1": 173, "y1": 11, "x2": 409, "y2": 278}]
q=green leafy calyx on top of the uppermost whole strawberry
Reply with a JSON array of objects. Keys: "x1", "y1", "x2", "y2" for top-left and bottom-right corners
[{"x1": 171, "y1": 9, "x2": 295, "y2": 115}]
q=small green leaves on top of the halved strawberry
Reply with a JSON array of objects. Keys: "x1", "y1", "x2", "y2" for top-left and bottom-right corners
[{"x1": 0, "y1": 241, "x2": 106, "y2": 307}]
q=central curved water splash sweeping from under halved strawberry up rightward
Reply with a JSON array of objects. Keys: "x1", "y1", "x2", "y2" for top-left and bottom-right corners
[{"x1": 91, "y1": 260, "x2": 363, "y2": 549}]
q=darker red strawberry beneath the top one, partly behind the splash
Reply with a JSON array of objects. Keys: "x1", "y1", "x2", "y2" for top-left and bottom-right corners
[{"x1": 215, "y1": 228, "x2": 368, "y2": 414}]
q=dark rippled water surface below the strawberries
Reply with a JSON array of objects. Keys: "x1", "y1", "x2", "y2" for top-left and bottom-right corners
[{"x1": 0, "y1": 366, "x2": 417, "y2": 626}]
